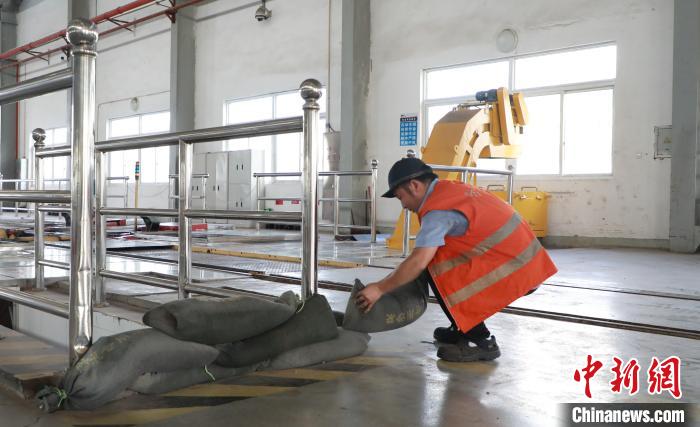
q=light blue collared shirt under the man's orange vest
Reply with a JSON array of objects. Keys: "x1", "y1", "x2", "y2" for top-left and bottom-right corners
[{"x1": 416, "y1": 179, "x2": 469, "y2": 248}]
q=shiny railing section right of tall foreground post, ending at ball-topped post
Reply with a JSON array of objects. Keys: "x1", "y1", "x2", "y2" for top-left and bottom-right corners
[{"x1": 95, "y1": 80, "x2": 320, "y2": 304}]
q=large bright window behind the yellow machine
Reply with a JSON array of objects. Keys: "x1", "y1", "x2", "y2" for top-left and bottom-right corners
[{"x1": 423, "y1": 45, "x2": 617, "y2": 175}]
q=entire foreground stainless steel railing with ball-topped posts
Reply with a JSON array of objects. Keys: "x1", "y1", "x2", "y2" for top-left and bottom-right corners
[{"x1": 0, "y1": 20, "x2": 321, "y2": 365}]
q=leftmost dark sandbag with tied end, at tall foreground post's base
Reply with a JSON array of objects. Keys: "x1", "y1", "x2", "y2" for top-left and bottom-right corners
[{"x1": 37, "y1": 328, "x2": 219, "y2": 412}]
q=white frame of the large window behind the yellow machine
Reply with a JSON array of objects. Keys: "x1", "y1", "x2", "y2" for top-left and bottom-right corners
[{"x1": 419, "y1": 41, "x2": 619, "y2": 180}]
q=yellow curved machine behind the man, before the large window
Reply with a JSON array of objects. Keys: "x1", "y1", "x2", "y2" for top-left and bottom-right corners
[{"x1": 387, "y1": 88, "x2": 527, "y2": 249}]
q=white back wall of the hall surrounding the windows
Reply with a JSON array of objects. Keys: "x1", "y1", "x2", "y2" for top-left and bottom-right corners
[{"x1": 12, "y1": 0, "x2": 673, "y2": 244}]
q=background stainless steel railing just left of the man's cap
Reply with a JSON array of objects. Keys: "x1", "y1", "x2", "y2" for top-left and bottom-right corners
[{"x1": 253, "y1": 159, "x2": 379, "y2": 243}]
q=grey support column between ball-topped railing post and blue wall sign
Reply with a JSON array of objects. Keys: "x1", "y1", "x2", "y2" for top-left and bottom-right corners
[{"x1": 340, "y1": 0, "x2": 370, "y2": 231}]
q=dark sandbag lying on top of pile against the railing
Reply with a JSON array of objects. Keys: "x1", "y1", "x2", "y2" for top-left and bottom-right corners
[{"x1": 143, "y1": 291, "x2": 297, "y2": 345}]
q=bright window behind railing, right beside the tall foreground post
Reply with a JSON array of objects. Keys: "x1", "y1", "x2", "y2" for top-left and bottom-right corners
[{"x1": 107, "y1": 111, "x2": 170, "y2": 183}]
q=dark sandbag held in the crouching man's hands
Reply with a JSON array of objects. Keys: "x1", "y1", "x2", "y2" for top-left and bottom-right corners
[{"x1": 343, "y1": 273, "x2": 428, "y2": 332}]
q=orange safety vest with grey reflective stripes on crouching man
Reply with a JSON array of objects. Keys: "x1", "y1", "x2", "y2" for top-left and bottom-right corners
[{"x1": 418, "y1": 181, "x2": 557, "y2": 332}]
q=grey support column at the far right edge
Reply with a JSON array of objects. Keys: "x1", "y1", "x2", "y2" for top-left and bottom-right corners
[{"x1": 669, "y1": 0, "x2": 700, "y2": 253}]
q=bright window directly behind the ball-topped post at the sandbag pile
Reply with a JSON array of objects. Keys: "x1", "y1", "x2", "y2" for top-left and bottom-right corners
[{"x1": 224, "y1": 89, "x2": 328, "y2": 179}]
